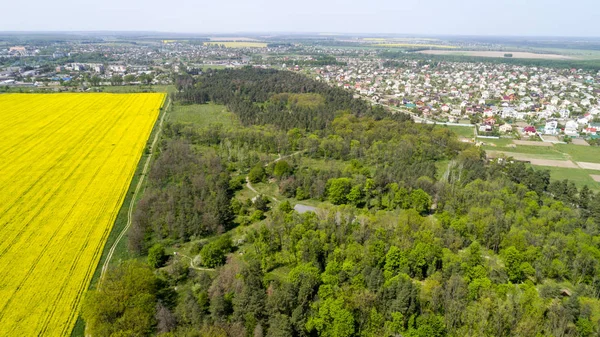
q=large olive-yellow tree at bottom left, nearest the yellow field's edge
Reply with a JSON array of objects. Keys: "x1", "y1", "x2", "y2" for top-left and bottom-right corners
[{"x1": 82, "y1": 260, "x2": 158, "y2": 337}]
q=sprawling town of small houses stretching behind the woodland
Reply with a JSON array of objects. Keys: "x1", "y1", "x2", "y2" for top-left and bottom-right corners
[{"x1": 0, "y1": 33, "x2": 600, "y2": 143}]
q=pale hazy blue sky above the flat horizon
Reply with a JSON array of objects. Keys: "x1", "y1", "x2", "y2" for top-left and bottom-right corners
[{"x1": 0, "y1": 0, "x2": 600, "y2": 37}]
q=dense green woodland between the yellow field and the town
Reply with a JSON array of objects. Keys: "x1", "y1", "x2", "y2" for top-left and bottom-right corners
[{"x1": 83, "y1": 69, "x2": 600, "y2": 337}]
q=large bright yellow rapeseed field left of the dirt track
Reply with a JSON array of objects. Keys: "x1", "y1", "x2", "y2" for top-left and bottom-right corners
[{"x1": 0, "y1": 94, "x2": 165, "y2": 336}]
